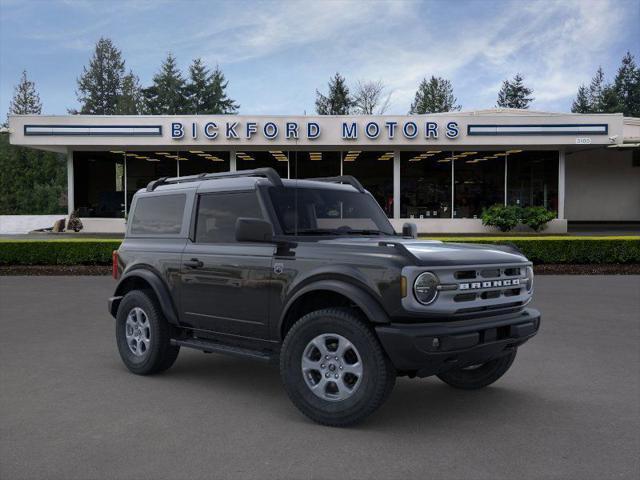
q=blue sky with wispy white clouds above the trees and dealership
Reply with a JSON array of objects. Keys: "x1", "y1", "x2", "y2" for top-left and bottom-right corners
[{"x1": 0, "y1": 0, "x2": 640, "y2": 117}]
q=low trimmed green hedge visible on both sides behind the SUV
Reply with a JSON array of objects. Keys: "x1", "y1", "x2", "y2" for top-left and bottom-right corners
[{"x1": 0, "y1": 236, "x2": 640, "y2": 265}]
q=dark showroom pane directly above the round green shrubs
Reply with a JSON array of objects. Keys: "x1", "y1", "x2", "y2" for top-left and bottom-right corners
[{"x1": 507, "y1": 150, "x2": 558, "y2": 211}]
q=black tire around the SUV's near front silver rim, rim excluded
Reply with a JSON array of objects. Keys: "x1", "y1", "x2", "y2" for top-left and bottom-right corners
[{"x1": 280, "y1": 308, "x2": 396, "y2": 427}]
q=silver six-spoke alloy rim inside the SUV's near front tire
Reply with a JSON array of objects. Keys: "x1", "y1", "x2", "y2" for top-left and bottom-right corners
[{"x1": 301, "y1": 333, "x2": 364, "y2": 401}]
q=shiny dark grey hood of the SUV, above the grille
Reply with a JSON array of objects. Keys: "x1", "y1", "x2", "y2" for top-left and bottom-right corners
[{"x1": 319, "y1": 237, "x2": 528, "y2": 266}]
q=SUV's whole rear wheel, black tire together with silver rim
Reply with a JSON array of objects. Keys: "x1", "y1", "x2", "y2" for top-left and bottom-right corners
[{"x1": 116, "y1": 290, "x2": 180, "y2": 375}]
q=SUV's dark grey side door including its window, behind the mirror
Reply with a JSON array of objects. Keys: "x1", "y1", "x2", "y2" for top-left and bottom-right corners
[{"x1": 181, "y1": 190, "x2": 275, "y2": 340}]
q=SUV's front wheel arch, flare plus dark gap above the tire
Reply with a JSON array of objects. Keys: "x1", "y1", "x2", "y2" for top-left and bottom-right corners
[{"x1": 278, "y1": 280, "x2": 389, "y2": 340}]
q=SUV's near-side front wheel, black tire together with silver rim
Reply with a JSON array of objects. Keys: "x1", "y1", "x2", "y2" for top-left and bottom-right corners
[{"x1": 280, "y1": 308, "x2": 396, "y2": 427}]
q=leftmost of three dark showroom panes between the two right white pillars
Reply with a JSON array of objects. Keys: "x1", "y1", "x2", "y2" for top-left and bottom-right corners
[{"x1": 400, "y1": 150, "x2": 452, "y2": 218}]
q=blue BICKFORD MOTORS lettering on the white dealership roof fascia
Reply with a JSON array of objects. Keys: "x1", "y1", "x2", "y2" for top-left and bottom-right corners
[{"x1": 171, "y1": 120, "x2": 460, "y2": 140}]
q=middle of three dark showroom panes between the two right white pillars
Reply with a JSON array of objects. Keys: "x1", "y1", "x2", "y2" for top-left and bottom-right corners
[{"x1": 452, "y1": 151, "x2": 506, "y2": 218}]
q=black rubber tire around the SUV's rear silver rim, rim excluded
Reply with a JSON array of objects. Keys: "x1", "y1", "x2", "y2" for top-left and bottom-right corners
[{"x1": 116, "y1": 290, "x2": 180, "y2": 375}]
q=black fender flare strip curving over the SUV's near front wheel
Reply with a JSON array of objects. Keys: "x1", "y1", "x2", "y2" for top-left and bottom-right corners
[{"x1": 278, "y1": 279, "x2": 390, "y2": 331}]
